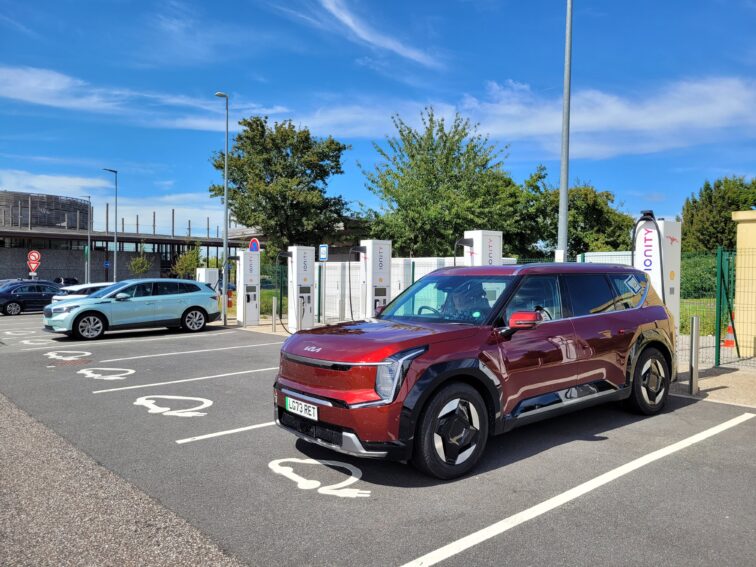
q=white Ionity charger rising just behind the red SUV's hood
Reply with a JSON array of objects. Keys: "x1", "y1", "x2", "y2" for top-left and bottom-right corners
[{"x1": 360, "y1": 240, "x2": 391, "y2": 319}]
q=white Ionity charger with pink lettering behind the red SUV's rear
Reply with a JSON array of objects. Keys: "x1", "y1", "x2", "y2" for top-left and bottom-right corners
[{"x1": 632, "y1": 211, "x2": 682, "y2": 332}]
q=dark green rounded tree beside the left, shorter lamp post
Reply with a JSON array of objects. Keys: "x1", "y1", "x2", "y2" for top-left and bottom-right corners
[{"x1": 210, "y1": 116, "x2": 349, "y2": 253}]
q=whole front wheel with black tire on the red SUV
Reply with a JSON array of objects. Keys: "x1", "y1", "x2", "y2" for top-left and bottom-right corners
[{"x1": 412, "y1": 382, "x2": 488, "y2": 480}]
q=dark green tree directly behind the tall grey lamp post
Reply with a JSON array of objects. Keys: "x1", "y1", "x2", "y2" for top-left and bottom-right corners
[{"x1": 541, "y1": 183, "x2": 634, "y2": 256}]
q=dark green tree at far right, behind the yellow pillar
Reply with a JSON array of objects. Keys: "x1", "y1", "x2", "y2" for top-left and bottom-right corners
[{"x1": 682, "y1": 177, "x2": 756, "y2": 252}]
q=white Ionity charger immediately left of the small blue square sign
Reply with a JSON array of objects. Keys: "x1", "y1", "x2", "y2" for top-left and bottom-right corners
[{"x1": 288, "y1": 246, "x2": 315, "y2": 333}]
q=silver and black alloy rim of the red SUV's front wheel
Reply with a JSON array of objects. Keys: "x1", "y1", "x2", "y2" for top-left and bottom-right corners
[{"x1": 433, "y1": 398, "x2": 480, "y2": 465}]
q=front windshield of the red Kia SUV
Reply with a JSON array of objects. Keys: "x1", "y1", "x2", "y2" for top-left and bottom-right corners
[{"x1": 379, "y1": 275, "x2": 514, "y2": 325}]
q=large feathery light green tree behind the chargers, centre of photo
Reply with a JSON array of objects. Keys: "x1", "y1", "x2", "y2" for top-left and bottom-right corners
[{"x1": 363, "y1": 108, "x2": 540, "y2": 256}]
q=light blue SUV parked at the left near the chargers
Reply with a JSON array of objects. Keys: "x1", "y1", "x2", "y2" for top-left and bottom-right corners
[{"x1": 44, "y1": 279, "x2": 220, "y2": 340}]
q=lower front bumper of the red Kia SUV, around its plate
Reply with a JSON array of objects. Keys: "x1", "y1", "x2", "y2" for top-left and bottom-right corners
[{"x1": 274, "y1": 383, "x2": 412, "y2": 461}]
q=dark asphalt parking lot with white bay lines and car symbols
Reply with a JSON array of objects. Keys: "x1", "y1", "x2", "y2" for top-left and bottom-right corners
[{"x1": 0, "y1": 314, "x2": 756, "y2": 565}]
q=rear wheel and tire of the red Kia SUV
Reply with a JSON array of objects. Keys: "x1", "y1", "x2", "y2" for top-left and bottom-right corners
[{"x1": 627, "y1": 348, "x2": 671, "y2": 415}]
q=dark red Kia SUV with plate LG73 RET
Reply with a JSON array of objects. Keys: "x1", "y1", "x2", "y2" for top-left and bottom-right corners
[{"x1": 274, "y1": 264, "x2": 675, "y2": 479}]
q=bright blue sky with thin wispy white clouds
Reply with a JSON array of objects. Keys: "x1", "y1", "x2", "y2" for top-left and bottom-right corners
[{"x1": 0, "y1": 0, "x2": 756, "y2": 232}]
